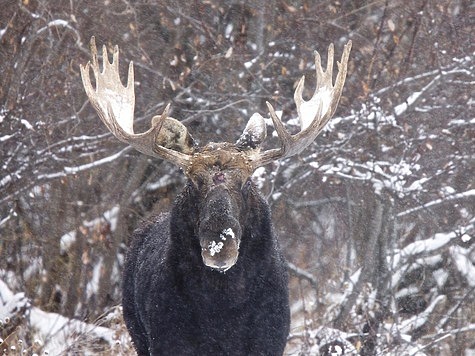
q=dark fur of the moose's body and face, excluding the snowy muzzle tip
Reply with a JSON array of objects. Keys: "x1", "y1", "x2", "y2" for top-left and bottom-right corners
[{"x1": 123, "y1": 159, "x2": 290, "y2": 356}]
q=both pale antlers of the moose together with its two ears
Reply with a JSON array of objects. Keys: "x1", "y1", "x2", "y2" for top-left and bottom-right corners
[{"x1": 80, "y1": 37, "x2": 351, "y2": 172}]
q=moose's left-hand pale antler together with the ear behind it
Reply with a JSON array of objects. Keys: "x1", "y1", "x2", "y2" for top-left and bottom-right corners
[{"x1": 80, "y1": 37, "x2": 193, "y2": 170}]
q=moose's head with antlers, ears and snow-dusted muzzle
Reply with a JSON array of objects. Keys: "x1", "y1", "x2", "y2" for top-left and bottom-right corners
[{"x1": 81, "y1": 37, "x2": 351, "y2": 271}]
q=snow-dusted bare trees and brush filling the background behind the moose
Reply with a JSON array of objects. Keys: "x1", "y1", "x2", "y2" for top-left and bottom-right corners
[{"x1": 0, "y1": 0, "x2": 475, "y2": 354}]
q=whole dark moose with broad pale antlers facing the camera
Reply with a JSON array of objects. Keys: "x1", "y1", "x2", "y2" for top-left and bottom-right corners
[{"x1": 80, "y1": 37, "x2": 351, "y2": 355}]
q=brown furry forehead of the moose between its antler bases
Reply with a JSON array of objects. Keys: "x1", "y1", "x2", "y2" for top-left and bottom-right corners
[{"x1": 186, "y1": 143, "x2": 253, "y2": 184}]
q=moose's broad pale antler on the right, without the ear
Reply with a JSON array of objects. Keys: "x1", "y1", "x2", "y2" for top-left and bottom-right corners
[{"x1": 251, "y1": 41, "x2": 351, "y2": 168}]
